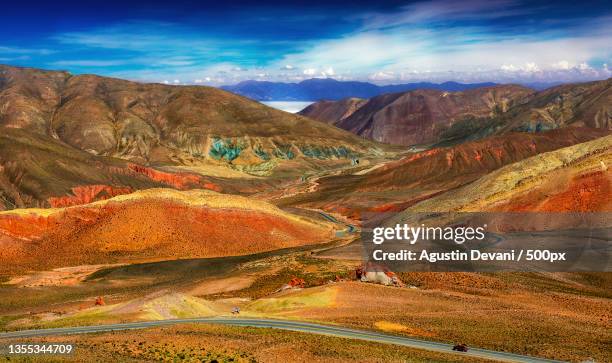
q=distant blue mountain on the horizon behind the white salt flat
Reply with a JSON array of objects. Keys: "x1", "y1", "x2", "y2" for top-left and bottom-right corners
[{"x1": 221, "y1": 78, "x2": 495, "y2": 101}]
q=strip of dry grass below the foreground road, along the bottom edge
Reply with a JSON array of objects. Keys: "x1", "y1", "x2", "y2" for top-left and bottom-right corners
[{"x1": 0, "y1": 325, "x2": 486, "y2": 363}]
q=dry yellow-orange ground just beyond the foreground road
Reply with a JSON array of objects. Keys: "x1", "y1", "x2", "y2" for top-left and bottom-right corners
[{"x1": 6, "y1": 252, "x2": 612, "y2": 361}]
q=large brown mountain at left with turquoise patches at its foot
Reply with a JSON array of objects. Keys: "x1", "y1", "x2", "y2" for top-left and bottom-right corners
[{"x1": 0, "y1": 66, "x2": 385, "y2": 209}]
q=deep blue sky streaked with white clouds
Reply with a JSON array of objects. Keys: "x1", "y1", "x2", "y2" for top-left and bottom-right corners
[{"x1": 0, "y1": 0, "x2": 612, "y2": 85}]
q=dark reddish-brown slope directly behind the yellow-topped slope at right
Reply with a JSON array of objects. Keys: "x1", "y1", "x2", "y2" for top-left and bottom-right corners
[{"x1": 282, "y1": 127, "x2": 610, "y2": 221}]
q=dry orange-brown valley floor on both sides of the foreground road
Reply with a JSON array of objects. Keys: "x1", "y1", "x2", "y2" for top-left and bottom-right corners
[{"x1": 0, "y1": 246, "x2": 612, "y2": 361}]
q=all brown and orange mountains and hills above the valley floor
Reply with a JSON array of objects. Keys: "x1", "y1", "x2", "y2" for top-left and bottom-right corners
[{"x1": 0, "y1": 66, "x2": 612, "y2": 282}]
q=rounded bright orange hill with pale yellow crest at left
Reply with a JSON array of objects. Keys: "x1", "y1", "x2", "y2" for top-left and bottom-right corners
[{"x1": 0, "y1": 189, "x2": 336, "y2": 274}]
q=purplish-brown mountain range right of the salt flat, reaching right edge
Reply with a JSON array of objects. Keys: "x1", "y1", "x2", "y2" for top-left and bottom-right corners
[{"x1": 299, "y1": 79, "x2": 612, "y2": 146}]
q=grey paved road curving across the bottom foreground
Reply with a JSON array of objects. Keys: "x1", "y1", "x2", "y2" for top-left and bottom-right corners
[{"x1": 0, "y1": 317, "x2": 558, "y2": 363}]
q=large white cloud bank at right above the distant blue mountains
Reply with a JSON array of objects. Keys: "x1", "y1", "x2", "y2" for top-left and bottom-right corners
[{"x1": 272, "y1": 18, "x2": 612, "y2": 82}]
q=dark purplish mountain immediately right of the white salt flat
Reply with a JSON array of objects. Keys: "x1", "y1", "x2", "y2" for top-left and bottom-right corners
[{"x1": 300, "y1": 85, "x2": 534, "y2": 145}]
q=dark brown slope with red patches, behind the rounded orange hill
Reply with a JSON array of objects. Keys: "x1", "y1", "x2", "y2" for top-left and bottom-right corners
[{"x1": 0, "y1": 128, "x2": 265, "y2": 210}]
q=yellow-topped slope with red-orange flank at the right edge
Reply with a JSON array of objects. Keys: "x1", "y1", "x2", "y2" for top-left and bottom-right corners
[{"x1": 387, "y1": 135, "x2": 612, "y2": 233}]
